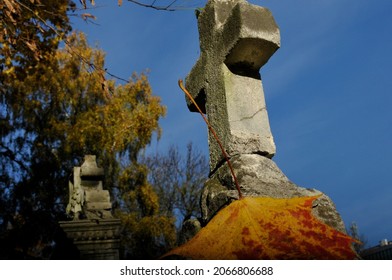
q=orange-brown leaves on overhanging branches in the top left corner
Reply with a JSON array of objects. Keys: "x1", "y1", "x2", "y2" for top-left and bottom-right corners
[{"x1": 0, "y1": 0, "x2": 70, "y2": 73}]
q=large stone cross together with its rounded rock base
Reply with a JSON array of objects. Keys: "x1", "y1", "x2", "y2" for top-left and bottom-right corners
[{"x1": 185, "y1": 0, "x2": 345, "y2": 236}]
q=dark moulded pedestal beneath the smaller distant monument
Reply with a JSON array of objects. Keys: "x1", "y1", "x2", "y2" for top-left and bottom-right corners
[{"x1": 59, "y1": 219, "x2": 120, "y2": 260}]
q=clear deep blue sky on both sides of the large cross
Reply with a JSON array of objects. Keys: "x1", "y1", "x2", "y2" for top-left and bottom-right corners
[{"x1": 73, "y1": 0, "x2": 392, "y2": 248}]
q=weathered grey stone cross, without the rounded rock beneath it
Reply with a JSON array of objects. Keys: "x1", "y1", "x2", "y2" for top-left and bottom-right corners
[{"x1": 185, "y1": 0, "x2": 280, "y2": 172}]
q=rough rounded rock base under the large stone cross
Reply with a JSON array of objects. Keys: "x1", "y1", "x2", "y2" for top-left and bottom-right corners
[{"x1": 201, "y1": 154, "x2": 345, "y2": 232}]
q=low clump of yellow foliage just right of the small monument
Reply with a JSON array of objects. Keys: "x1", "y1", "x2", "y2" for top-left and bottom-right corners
[{"x1": 117, "y1": 164, "x2": 176, "y2": 259}]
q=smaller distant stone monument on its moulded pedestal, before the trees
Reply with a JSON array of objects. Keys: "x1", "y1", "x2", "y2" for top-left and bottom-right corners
[{"x1": 60, "y1": 155, "x2": 120, "y2": 259}]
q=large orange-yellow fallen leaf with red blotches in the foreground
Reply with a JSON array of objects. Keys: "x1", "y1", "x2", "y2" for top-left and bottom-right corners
[{"x1": 162, "y1": 196, "x2": 357, "y2": 259}]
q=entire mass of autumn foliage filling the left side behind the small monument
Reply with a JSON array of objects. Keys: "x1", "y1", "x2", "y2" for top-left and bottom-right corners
[{"x1": 0, "y1": 0, "x2": 202, "y2": 259}]
